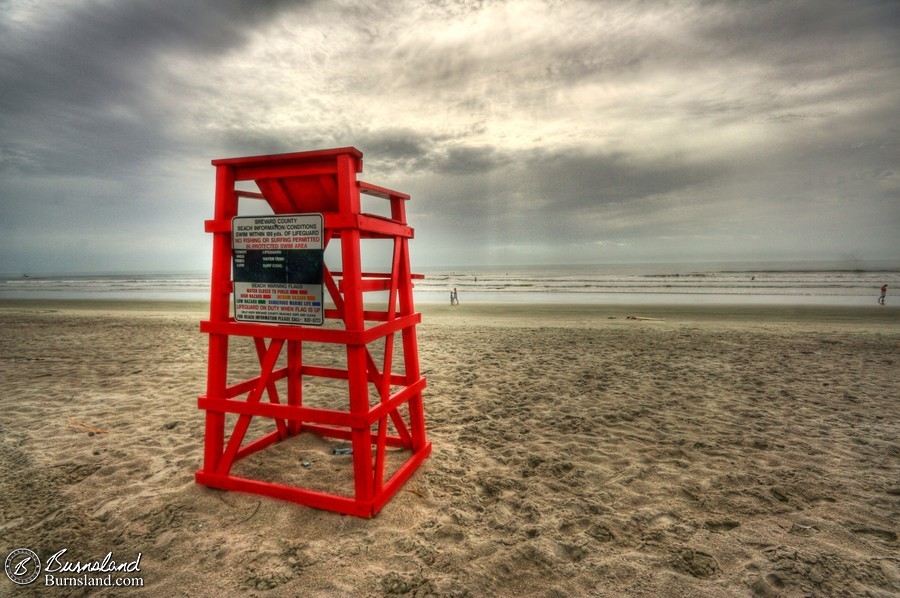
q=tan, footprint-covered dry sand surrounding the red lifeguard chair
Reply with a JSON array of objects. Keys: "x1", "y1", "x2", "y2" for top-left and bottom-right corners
[{"x1": 0, "y1": 302, "x2": 900, "y2": 597}]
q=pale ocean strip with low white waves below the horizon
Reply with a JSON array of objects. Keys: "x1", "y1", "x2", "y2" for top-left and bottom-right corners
[{"x1": 0, "y1": 262, "x2": 900, "y2": 305}]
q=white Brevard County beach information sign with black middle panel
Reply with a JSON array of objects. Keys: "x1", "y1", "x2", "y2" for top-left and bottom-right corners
[{"x1": 231, "y1": 214, "x2": 325, "y2": 326}]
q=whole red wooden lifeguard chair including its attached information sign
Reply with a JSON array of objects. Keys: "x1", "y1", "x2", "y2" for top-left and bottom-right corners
[{"x1": 196, "y1": 147, "x2": 431, "y2": 517}]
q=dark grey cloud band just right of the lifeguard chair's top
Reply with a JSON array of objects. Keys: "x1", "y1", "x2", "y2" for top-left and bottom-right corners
[{"x1": 406, "y1": 149, "x2": 730, "y2": 244}]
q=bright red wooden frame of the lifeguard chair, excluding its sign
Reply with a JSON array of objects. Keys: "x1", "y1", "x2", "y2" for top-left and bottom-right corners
[{"x1": 196, "y1": 147, "x2": 431, "y2": 517}]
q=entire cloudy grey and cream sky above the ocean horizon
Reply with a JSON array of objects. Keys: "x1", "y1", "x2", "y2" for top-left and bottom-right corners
[{"x1": 0, "y1": 0, "x2": 900, "y2": 274}]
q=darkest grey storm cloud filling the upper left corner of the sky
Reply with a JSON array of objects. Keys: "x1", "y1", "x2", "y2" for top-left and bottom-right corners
[{"x1": 0, "y1": 0, "x2": 306, "y2": 174}]
